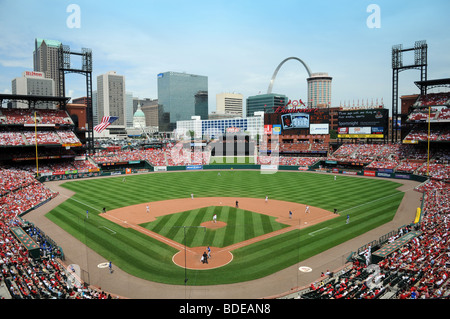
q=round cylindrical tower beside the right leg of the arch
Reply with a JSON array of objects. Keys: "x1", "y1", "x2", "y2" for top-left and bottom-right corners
[{"x1": 306, "y1": 72, "x2": 332, "y2": 107}]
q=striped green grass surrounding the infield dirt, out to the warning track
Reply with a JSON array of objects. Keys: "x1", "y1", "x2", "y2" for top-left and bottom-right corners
[{"x1": 46, "y1": 170, "x2": 403, "y2": 285}]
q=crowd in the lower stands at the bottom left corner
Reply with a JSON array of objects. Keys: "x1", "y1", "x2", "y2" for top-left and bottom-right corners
[{"x1": 0, "y1": 167, "x2": 116, "y2": 299}]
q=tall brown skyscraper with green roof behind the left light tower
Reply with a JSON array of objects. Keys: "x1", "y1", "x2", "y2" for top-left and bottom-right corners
[{"x1": 33, "y1": 38, "x2": 61, "y2": 95}]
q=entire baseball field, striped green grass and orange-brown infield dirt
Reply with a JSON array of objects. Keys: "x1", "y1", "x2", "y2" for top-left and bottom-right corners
[{"x1": 46, "y1": 170, "x2": 404, "y2": 285}]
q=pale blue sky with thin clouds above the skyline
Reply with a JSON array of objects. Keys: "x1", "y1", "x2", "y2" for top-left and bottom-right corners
[{"x1": 0, "y1": 0, "x2": 450, "y2": 112}]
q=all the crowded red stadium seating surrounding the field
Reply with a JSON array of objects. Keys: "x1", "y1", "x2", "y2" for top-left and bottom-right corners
[{"x1": 0, "y1": 120, "x2": 450, "y2": 299}]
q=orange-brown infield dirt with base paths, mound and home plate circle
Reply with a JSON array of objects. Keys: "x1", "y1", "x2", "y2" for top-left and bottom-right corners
[{"x1": 100, "y1": 197, "x2": 339, "y2": 269}]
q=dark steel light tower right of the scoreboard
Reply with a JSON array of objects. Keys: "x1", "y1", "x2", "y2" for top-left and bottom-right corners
[{"x1": 391, "y1": 40, "x2": 428, "y2": 143}]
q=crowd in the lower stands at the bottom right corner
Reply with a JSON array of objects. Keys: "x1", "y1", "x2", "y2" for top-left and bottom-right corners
[{"x1": 300, "y1": 180, "x2": 450, "y2": 299}]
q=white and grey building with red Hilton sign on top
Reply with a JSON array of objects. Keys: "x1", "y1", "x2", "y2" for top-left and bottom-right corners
[{"x1": 11, "y1": 71, "x2": 56, "y2": 109}]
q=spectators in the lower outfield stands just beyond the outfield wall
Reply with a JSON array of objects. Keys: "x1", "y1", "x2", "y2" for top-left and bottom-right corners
[{"x1": 87, "y1": 143, "x2": 449, "y2": 181}]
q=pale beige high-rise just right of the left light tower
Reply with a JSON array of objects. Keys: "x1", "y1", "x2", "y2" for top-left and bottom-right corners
[{"x1": 97, "y1": 71, "x2": 127, "y2": 132}]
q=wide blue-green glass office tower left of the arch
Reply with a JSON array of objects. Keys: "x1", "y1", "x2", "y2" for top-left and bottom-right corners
[{"x1": 158, "y1": 72, "x2": 208, "y2": 131}]
